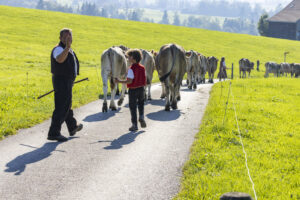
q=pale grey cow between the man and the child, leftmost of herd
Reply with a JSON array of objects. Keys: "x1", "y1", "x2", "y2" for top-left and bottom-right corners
[{"x1": 101, "y1": 46, "x2": 128, "y2": 112}]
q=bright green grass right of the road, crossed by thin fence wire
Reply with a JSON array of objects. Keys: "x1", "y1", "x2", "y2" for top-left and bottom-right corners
[{"x1": 175, "y1": 78, "x2": 300, "y2": 200}]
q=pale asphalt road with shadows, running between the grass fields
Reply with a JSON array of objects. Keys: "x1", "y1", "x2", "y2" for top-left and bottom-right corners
[{"x1": 0, "y1": 84, "x2": 212, "y2": 200}]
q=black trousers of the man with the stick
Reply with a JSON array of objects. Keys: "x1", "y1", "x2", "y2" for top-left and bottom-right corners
[{"x1": 48, "y1": 76, "x2": 77, "y2": 136}]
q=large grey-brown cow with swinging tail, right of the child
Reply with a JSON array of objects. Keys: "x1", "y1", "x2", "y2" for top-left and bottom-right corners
[{"x1": 155, "y1": 44, "x2": 187, "y2": 111}]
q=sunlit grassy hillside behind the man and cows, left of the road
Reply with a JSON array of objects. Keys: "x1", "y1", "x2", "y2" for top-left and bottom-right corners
[{"x1": 0, "y1": 6, "x2": 300, "y2": 138}]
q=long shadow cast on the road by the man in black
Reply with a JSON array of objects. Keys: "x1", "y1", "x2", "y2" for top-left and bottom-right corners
[{"x1": 4, "y1": 137, "x2": 76, "y2": 175}]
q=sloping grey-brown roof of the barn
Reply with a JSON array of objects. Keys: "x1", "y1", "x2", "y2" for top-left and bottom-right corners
[{"x1": 268, "y1": 0, "x2": 300, "y2": 23}]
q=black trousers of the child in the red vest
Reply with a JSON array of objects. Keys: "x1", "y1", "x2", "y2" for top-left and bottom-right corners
[{"x1": 128, "y1": 87, "x2": 145, "y2": 125}]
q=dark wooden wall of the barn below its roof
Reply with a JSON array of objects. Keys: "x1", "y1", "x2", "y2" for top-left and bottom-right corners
[{"x1": 268, "y1": 22, "x2": 298, "y2": 40}]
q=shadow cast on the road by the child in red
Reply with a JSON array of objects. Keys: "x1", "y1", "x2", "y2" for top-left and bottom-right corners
[{"x1": 98, "y1": 131, "x2": 145, "y2": 150}]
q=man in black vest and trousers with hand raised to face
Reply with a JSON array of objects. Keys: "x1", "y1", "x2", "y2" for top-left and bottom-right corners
[{"x1": 47, "y1": 28, "x2": 83, "y2": 142}]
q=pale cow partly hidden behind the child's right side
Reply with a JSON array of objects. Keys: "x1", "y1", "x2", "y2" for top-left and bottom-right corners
[{"x1": 141, "y1": 49, "x2": 155, "y2": 100}]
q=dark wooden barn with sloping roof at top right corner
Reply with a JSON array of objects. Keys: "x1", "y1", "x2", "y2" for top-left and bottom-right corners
[{"x1": 267, "y1": 0, "x2": 300, "y2": 40}]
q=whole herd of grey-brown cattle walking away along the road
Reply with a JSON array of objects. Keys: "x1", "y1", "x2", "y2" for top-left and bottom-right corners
[{"x1": 101, "y1": 44, "x2": 300, "y2": 112}]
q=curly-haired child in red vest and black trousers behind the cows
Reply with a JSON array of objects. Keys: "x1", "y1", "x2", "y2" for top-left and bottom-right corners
[{"x1": 115, "y1": 49, "x2": 147, "y2": 131}]
